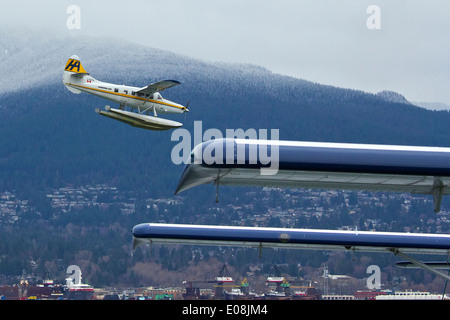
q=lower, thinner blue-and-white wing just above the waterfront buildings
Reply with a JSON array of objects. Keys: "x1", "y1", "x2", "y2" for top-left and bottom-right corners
[{"x1": 132, "y1": 223, "x2": 450, "y2": 254}]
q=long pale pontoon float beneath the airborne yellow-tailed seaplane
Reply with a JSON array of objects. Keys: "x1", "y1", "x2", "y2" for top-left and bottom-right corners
[{"x1": 95, "y1": 106, "x2": 183, "y2": 131}]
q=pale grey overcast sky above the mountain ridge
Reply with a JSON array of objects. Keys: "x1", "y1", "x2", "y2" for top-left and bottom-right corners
[{"x1": 0, "y1": 0, "x2": 450, "y2": 104}]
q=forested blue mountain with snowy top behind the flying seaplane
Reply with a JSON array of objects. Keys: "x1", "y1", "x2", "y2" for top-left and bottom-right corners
[{"x1": 0, "y1": 30, "x2": 450, "y2": 194}]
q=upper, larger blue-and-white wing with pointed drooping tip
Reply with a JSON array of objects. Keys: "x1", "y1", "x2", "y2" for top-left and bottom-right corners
[{"x1": 175, "y1": 139, "x2": 450, "y2": 212}]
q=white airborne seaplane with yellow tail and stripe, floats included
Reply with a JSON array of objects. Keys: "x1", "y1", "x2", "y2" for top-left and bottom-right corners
[{"x1": 63, "y1": 55, "x2": 189, "y2": 131}]
